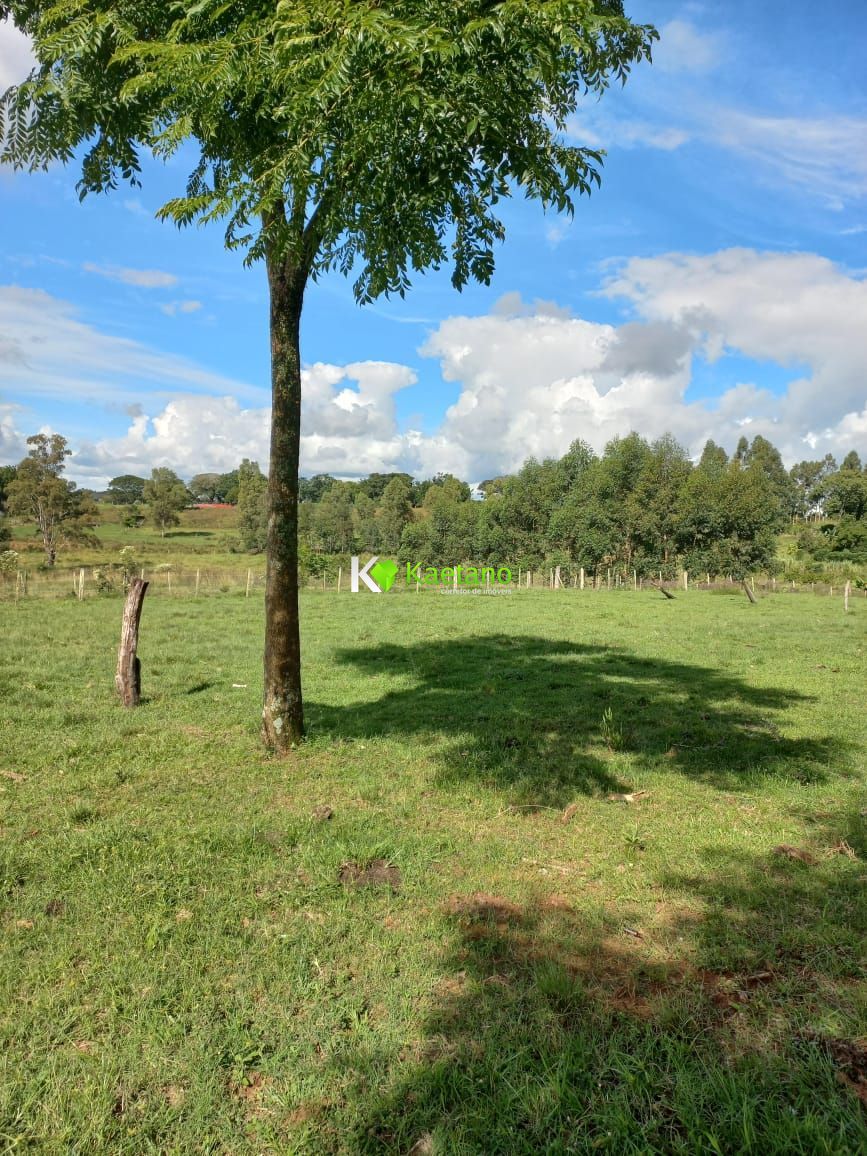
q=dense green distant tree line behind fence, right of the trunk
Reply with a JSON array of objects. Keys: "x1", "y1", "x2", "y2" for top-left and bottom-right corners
[{"x1": 293, "y1": 434, "x2": 867, "y2": 577}]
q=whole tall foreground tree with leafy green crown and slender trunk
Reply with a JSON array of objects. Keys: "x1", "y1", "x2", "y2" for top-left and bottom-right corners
[{"x1": 0, "y1": 0, "x2": 657, "y2": 750}]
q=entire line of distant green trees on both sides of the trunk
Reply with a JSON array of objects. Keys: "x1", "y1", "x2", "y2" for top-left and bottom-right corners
[{"x1": 0, "y1": 434, "x2": 867, "y2": 568}]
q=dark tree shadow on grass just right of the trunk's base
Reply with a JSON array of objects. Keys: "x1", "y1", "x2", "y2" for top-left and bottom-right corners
[{"x1": 309, "y1": 635, "x2": 843, "y2": 806}]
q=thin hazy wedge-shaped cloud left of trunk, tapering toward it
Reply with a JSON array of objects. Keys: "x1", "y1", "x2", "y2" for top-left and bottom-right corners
[{"x1": 0, "y1": 286, "x2": 266, "y2": 401}]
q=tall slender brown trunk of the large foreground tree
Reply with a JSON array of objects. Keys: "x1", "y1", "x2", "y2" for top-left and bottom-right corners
[{"x1": 262, "y1": 254, "x2": 306, "y2": 753}]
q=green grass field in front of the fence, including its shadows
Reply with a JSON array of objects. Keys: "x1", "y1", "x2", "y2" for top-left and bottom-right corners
[{"x1": 0, "y1": 592, "x2": 867, "y2": 1156}]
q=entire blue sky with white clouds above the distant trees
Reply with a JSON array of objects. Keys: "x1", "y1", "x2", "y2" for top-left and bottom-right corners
[{"x1": 0, "y1": 0, "x2": 867, "y2": 486}]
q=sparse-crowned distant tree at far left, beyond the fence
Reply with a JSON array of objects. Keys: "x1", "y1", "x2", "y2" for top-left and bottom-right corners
[{"x1": 7, "y1": 434, "x2": 96, "y2": 566}]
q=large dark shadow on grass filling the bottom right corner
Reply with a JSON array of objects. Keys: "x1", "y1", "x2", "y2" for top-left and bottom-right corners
[{"x1": 344, "y1": 809, "x2": 867, "y2": 1156}]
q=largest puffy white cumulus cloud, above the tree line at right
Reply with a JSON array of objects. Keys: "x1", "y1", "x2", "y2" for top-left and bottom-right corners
[{"x1": 422, "y1": 250, "x2": 867, "y2": 479}]
